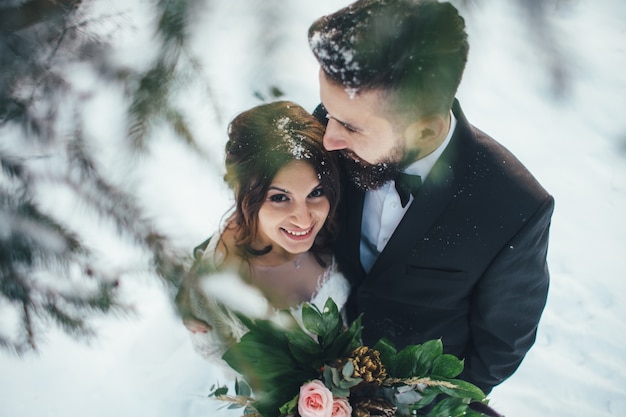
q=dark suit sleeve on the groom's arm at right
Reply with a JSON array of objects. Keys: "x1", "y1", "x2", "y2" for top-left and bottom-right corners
[{"x1": 460, "y1": 196, "x2": 554, "y2": 393}]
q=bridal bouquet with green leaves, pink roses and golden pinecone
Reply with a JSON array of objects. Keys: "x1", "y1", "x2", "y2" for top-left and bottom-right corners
[{"x1": 211, "y1": 298, "x2": 498, "y2": 417}]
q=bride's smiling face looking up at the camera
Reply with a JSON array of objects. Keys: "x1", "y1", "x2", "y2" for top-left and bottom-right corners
[{"x1": 255, "y1": 160, "x2": 330, "y2": 254}]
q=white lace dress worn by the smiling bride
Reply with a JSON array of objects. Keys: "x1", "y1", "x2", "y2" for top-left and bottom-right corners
[{"x1": 189, "y1": 238, "x2": 350, "y2": 363}]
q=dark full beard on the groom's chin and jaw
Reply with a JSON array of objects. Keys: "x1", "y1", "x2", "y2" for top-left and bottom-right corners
[{"x1": 339, "y1": 150, "x2": 419, "y2": 191}]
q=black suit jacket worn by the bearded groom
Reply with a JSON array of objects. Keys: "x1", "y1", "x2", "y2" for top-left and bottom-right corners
[{"x1": 335, "y1": 101, "x2": 554, "y2": 392}]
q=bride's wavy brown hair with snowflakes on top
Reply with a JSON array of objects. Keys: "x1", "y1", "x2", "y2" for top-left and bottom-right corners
[{"x1": 224, "y1": 101, "x2": 340, "y2": 260}]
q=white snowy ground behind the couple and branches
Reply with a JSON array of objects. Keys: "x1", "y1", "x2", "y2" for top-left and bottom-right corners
[{"x1": 0, "y1": 0, "x2": 626, "y2": 417}]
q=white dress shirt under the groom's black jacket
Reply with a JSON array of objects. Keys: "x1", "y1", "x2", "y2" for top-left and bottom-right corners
[{"x1": 360, "y1": 112, "x2": 456, "y2": 272}]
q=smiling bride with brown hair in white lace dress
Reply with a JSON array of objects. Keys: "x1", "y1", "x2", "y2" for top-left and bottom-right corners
[{"x1": 176, "y1": 101, "x2": 349, "y2": 358}]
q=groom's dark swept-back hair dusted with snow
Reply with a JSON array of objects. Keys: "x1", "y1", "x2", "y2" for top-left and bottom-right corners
[{"x1": 309, "y1": 0, "x2": 469, "y2": 117}]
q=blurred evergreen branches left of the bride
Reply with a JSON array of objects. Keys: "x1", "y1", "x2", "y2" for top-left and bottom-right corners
[{"x1": 0, "y1": 0, "x2": 216, "y2": 354}]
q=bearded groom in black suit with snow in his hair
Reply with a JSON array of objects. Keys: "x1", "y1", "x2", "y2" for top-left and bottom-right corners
[{"x1": 309, "y1": 0, "x2": 554, "y2": 393}]
